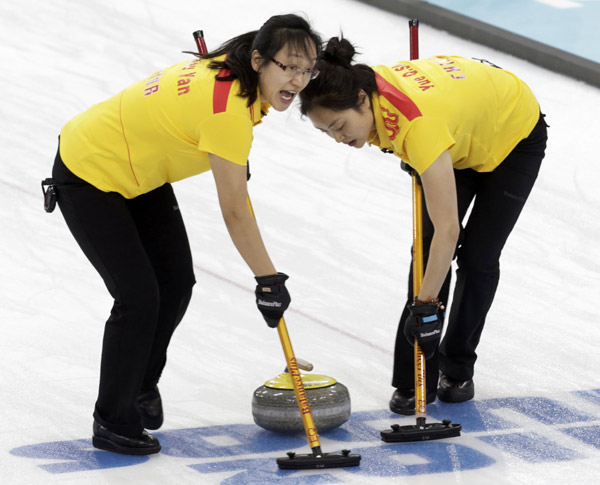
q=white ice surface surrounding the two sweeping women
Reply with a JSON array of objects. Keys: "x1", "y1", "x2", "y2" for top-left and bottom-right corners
[{"x1": 0, "y1": 0, "x2": 600, "y2": 484}]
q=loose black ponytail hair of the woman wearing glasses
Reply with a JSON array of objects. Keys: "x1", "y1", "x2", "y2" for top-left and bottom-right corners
[{"x1": 195, "y1": 14, "x2": 322, "y2": 106}]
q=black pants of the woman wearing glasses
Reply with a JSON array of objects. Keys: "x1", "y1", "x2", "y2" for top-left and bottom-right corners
[{"x1": 52, "y1": 147, "x2": 195, "y2": 436}]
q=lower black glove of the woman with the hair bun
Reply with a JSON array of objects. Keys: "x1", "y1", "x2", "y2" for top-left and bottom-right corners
[{"x1": 404, "y1": 303, "x2": 444, "y2": 359}]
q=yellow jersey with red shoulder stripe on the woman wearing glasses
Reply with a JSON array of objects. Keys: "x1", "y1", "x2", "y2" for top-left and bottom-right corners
[{"x1": 60, "y1": 57, "x2": 268, "y2": 198}]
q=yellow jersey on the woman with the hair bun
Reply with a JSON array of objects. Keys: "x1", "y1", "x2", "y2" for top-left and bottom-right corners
[{"x1": 371, "y1": 56, "x2": 540, "y2": 174}]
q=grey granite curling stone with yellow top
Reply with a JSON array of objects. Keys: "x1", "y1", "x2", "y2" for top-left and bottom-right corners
[{"x1": 252, "y1": 369, "x2": 350, "y2": 433}]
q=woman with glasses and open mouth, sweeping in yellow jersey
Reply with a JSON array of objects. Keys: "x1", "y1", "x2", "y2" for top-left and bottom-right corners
[{"x1": 52, "y1": 15, "x2": 321, "y2": 455}]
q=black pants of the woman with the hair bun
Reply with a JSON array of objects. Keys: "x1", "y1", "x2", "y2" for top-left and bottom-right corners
[{"x1": 392, "y1": 111, "x2": 548, "y2": 392}]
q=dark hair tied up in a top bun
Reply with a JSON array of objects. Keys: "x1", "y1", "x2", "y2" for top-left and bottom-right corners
[{"x1": 300, "y1": 37, "x2": 377, "y2": 115}]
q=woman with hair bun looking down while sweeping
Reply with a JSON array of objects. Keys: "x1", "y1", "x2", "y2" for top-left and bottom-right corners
[{"x1": 300, "y1": 37, "x2": 547, "y2": 415}]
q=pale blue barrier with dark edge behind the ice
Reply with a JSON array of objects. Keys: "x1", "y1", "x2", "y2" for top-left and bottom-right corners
[{"x1": 359, "y1": 0, "x2": 600, "y2": 87}]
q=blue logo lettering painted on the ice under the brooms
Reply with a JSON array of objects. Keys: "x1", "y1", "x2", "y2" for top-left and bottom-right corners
[{"x1": 11, "y1": 390, "x2": 600, "y2": 485}]
